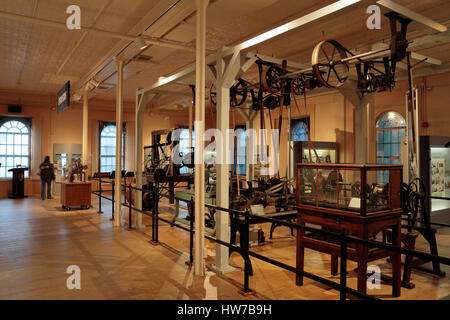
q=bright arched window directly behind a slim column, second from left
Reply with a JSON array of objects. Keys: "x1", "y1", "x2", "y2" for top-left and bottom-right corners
[{"x1": 99, "y1": 123, "x2": 125, "y2": 172}]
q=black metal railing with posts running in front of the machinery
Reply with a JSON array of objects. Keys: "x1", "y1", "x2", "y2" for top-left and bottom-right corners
[{"x1": 92, "y1": 178, "x2": 450, "y2": 300}]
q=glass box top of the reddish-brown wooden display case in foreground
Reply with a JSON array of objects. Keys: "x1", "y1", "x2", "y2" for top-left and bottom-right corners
[{"x1": 297, "y1": 163, "x2": 402, "y2": 216}]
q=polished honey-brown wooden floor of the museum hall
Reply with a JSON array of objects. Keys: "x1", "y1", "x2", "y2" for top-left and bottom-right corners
[{"x1": 0, "y1": 198, "x2": 450, "y2": 300}]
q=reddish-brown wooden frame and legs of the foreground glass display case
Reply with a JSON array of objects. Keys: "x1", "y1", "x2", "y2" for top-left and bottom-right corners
[{"x1": 296, "y1": 163, "x2": 403, "y2": 297}]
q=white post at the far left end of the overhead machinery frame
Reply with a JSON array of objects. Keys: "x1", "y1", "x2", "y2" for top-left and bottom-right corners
[{"x1": 133, "y1": 94, "x2": 147, "y2": 228}]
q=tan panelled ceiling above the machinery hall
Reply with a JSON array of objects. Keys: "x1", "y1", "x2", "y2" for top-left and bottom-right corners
[{"x1": 0, "y1": 0, "x2": 450, "y2": 112}]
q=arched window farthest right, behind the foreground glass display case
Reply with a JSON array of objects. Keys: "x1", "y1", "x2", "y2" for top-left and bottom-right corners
[{"x1": 376, "y1": 111, "x2": 406, "y2": 164}]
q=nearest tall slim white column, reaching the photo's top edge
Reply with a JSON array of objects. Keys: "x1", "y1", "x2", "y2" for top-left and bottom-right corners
[{"x1": 194, "y1": 0, "x2": 209, "y2": 276}]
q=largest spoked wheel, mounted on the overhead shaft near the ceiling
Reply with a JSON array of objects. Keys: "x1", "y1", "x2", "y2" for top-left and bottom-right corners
[{"x1": 311, "y1": 40, "x2": 349, "y2": 88}]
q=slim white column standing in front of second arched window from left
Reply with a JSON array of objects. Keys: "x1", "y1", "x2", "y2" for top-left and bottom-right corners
[{"x1": 114, "y1": 60, "x2": 123, "y2": 227}]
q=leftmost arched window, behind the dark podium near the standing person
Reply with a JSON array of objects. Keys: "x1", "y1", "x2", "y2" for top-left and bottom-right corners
[{"x1": 0, "y1": 119, "x2": 30, "y2": 178}]
